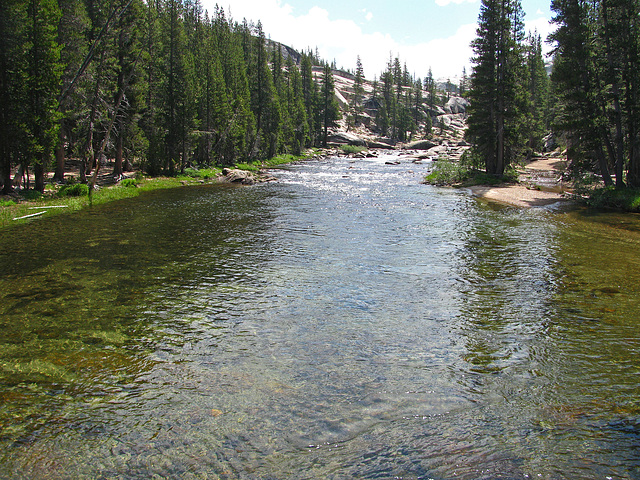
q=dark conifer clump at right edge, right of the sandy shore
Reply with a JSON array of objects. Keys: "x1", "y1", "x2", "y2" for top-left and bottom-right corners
[{"x1": 551, "y1": 0, "x2": 640, "y2": 187}]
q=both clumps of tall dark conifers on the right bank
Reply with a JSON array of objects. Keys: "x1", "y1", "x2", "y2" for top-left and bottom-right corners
[{"x1": 468, "y1": 0, "x2": 640, "y2": 187}]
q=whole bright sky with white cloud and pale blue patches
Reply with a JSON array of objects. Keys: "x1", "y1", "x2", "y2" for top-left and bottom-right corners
[{"x1": 201, "y1": 0, "x2": 552, "y2": 80}]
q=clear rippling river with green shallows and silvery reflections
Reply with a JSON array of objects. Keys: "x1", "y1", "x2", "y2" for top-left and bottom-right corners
[{"x1": 0, "y1": 156, "x2": 640, "y2": 480}]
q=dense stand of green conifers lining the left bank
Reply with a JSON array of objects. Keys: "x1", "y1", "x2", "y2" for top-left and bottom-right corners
[{"x1": 0, "y1": 0, "x2": 340, "y2": 193}]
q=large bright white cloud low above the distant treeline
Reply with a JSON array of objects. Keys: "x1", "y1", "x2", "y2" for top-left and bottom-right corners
[{"x1": 210, "y1": 0, "x2": 476, "y2": 79}]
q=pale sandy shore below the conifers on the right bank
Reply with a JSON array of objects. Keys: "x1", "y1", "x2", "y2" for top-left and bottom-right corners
[{"x1": 470, "y1": 158, "x2": 571, "y2": 208}]
